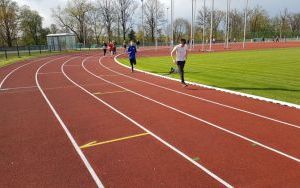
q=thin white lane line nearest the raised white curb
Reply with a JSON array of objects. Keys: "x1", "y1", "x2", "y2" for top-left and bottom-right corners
[{"x1": 111, "y1": 55, "x2": 300, "y2": 129}]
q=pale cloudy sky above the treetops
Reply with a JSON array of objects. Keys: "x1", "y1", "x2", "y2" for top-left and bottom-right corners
[{"x1": 16, "y1": 0, "x2": 300, "y2": 26}]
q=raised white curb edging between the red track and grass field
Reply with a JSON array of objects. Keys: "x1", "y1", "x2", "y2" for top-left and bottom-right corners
[{"x1": 114, "y1": 54, "x2": 300, "y2": 110}]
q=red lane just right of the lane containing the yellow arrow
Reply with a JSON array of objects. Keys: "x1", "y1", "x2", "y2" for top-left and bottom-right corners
[{"x1": 69, "y1": 54, "x2": 300, "y2": 187}]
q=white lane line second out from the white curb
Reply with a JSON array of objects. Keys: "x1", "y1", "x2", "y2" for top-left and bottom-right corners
[{"x1": 83, "y1": 58, "x2": 300, "y2": 163}]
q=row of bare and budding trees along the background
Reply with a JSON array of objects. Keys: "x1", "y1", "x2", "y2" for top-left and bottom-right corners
[{"x1": 0, "y1": 0, "x2": 300, "y2": 47}]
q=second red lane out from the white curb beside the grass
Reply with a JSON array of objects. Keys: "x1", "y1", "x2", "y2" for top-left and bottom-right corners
[{"x1": 99, "y1": 55, "x2": 300, "y2": 157}]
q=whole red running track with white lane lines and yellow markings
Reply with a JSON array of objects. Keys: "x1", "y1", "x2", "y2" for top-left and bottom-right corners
[{"x1": 0, "y1": 43, "x2": 300, "y2": 187}]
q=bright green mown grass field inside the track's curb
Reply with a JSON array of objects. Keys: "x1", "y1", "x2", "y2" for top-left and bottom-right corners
[{"x1": 121, "y1": 48, "x2": 300, "y2": 104}]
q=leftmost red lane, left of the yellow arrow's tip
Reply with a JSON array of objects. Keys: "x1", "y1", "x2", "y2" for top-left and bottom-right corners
[{"x1": 0, "y1": 56, "x2": 101, "y2": 187}]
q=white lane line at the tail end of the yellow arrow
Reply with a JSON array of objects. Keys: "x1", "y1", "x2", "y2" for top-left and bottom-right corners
[{"x1": 61, "y1": 57, "x2": 233, "y2": 187}]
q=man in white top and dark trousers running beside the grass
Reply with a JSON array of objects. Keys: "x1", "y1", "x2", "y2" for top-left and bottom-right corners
[{"x1": 171, "y1": 39, "x2": 188, "y2": 87}]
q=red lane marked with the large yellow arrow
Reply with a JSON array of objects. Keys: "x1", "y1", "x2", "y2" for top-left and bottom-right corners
[{"x1": 39, "y1": 54, "x2": 222, "y2": 187}]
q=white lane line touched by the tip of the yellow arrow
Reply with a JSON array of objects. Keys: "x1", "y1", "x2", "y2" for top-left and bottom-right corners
[{"x1": 35, "y1": 57, "x2": 104, "y2": 188}]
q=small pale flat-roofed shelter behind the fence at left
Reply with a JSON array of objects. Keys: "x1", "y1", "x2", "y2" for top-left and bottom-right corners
[{"x1": 47, "y1": 33, "x2": 76, "y2": 51}]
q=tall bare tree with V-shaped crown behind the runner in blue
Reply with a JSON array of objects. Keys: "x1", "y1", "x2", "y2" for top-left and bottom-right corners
[{"x1": 115, "y1": 0, "x2": 137, "y2": 40}]
